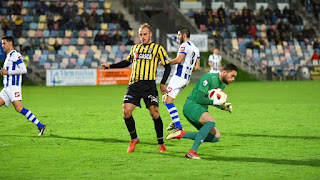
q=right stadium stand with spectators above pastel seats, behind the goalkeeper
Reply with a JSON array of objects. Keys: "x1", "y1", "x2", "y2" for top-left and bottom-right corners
[{"x1": 184, "y1": 2, "x2": 320, "y2": 78}]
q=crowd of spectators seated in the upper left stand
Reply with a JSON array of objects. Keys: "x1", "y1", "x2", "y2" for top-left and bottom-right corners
[{"x1": 0, "y1": 1, "x2": 133, "y2": 45}]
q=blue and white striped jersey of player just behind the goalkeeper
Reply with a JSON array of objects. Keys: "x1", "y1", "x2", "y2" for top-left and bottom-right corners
[{"x1": 174, "y1": 41, "x2": 200, "y2": 80}]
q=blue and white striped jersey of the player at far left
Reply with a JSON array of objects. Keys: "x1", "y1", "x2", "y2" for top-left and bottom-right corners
[{"x1": 3, "y1": 50, "x2": 27, "y2": 87}]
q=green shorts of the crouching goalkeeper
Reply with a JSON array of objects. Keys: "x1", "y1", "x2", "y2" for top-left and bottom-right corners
[{"x1": 183, "y1": 99, "x2": 208, "y2": 130}]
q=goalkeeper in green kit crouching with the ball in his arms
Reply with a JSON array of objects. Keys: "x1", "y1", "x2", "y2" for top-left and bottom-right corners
[{"x1": 166, "y1": 63, "x2": 238, "y2": 159}]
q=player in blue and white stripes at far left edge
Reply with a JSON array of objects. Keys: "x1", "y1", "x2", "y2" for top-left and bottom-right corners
[{"x1": 0, "y1": 36, "x2": 46, "y2": 136}]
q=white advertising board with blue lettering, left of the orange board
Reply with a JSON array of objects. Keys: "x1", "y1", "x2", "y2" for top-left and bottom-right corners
[{"x1": 46, "y1": 69, "x2": 97, "y2": 86}]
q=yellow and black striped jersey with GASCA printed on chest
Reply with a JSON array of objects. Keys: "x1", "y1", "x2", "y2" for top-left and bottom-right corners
[{"x1": 126, "y1": 43, "x2": 169, "y2": 85}]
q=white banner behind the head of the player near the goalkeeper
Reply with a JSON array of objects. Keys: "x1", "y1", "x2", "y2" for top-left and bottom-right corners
[{"x1": 167, "y1": 34, "x2": 208, "y2": 52}]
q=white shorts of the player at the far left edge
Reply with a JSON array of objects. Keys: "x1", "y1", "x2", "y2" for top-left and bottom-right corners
[{"x1": 0, "y1": 86, "x2": 22, "y2": 108}]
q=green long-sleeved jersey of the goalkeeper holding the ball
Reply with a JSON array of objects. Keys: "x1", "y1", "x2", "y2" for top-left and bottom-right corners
[{"x1": 188, "y1": 73, "x2": 226, "y2": 109}]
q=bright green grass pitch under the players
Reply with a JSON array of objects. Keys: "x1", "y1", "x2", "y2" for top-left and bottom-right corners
[{"x1": 0, "y1": 81, "x2": 320, "y2": 180}]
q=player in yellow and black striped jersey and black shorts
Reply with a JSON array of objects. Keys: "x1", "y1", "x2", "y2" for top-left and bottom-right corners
[{"x1": 101, "y1": 23, "x2": 171, "y2": 153}]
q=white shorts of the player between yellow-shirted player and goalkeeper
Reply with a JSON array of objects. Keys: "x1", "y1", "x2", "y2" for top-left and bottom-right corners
[{"x1": 167, "y1": 75, "x2": 189, "y2": 99}]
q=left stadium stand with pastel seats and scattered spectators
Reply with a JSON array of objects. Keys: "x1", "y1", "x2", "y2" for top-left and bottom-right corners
[{"x1": 0, "y1": 0, "x2": 134, "y2": 69}]
